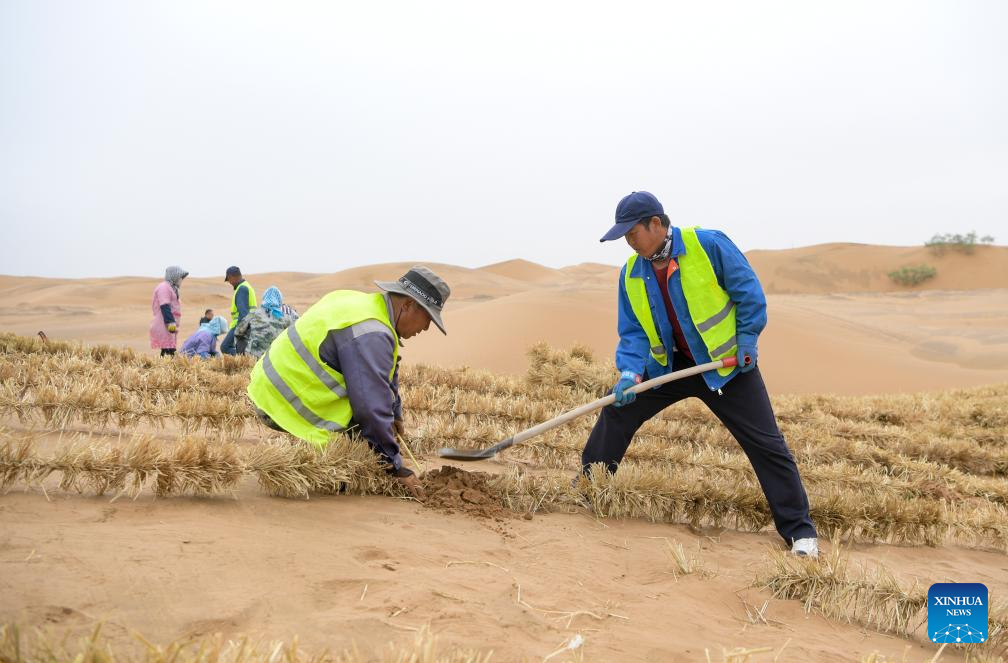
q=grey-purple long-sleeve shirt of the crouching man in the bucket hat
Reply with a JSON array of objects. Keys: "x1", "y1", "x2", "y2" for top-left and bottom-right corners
[{"x1": 319, "y1": 295, "x2": 402, "y2": 473}]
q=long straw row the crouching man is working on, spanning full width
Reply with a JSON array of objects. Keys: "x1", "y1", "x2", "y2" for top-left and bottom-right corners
[{"x1": 0, "y1": 423, "x2": 1008, "y2": 549}]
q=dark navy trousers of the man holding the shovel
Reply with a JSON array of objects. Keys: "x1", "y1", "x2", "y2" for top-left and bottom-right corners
[{"x1": 581, "y1": 353, "x2": 815, "y2": 543}]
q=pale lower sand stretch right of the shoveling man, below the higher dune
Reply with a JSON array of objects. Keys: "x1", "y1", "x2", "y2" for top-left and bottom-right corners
[{"x1": 760, "y1": 290, "x2": 1008, "y2": 394}]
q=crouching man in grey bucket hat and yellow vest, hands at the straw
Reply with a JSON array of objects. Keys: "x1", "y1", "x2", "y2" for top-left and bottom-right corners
[{"x1": 248, "y1": 266, "x2": 451, "y2": 499}]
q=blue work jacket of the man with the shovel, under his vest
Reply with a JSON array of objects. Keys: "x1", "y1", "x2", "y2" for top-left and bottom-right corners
[{"x1": 616, "y1": 227, "x2": 766, "y2": 391}]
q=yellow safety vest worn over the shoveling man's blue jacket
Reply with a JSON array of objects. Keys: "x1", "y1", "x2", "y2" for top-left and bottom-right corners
[{"x1": 623, "y1": 228, "x2": 738, "y2": 377}]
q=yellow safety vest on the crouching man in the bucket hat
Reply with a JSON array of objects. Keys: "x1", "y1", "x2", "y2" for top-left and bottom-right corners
[{"x1": 248, "y1": 290, "x2": 399, "y2": 447}]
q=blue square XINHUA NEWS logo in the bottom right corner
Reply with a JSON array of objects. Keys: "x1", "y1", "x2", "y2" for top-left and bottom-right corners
[{"x1": 927, "y1": 582, "x2": 987, "y2": 644}]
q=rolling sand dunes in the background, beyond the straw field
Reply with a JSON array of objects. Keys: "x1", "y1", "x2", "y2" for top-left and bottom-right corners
[{"x1": 0, "y1": 244, "x2": 1008, "y2": 394}]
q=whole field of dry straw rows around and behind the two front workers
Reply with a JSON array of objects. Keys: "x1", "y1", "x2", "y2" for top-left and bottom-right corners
[{"x1": 0, "y1": 335, "x2": 1008, "y2": 548}]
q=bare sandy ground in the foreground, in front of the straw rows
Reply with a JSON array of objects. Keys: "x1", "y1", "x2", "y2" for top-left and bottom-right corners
[{"x1": 7, "y1": 423, "x2": 1008, "y2": 661}]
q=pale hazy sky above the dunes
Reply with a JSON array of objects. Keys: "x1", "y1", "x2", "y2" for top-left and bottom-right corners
[{"x1": 0, "y1": 0, "x2": 1008, "y2": 278}]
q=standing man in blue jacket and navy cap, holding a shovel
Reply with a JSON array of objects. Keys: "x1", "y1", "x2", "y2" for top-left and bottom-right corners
[{"x1": 582, "y1": 191, "x2": 818, "y2": 557}]
